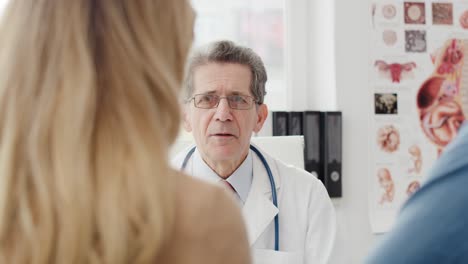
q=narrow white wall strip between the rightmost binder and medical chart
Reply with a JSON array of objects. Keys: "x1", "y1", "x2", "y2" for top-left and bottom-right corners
[{"x1": 332, "y1": 0, "x2": 376, "y2": 264}]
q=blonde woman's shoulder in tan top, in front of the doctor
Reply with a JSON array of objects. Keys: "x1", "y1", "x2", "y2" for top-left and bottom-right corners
[{"x1": 172, "y1": 172, "x2": 250, "y2": 263}]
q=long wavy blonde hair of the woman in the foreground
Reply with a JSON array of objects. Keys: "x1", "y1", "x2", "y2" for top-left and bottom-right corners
[{"x1": 0, "y1": 0, "x2": 193, "y2": 264}]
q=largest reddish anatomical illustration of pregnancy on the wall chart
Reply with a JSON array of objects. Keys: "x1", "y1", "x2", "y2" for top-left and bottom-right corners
[{"x1": 417, "y1": 39, "x2": 468, "y2": 154}]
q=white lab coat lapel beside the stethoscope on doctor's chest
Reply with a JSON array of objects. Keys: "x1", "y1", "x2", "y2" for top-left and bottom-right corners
[{"x1": 242, "y1": 147, "x2": 280, "y2": 245}]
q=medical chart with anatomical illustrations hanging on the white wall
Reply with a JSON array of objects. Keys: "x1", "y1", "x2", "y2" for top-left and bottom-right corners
[{"x1": 368, "y1": 0, "x2": 468, "y2": 233}]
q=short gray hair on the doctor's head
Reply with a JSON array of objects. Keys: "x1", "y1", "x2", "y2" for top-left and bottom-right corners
[{"x1": 184, "y1": 40, "x2": 267, "y2": 104}]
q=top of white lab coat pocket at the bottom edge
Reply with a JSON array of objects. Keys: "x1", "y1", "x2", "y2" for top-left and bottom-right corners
[{"x1": 253, "y1": 249, "x2": 304, "y2": 264}]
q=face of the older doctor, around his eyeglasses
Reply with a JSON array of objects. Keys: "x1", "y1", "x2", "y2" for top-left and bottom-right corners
[{"x1": 184, "y1": 63, "x2": 268, "y2": 165}]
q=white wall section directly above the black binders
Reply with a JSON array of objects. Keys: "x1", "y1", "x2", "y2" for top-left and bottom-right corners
[{"x1": 284, "y1": 0, "x2": 336, "y2": 111}]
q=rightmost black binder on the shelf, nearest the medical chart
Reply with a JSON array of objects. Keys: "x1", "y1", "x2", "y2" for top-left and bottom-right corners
[{"x1": 322, "y1": 112, "x2": 343, "y2": 197}]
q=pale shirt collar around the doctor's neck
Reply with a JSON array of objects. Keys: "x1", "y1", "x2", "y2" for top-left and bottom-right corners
[{"x1": 192, "y1": 149, "x2": 253, "y2": 205}]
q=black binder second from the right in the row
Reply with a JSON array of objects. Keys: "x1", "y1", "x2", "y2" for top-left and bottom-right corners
[{"x1": 302, "y1": 111, "x2": 325, "y2": 184}]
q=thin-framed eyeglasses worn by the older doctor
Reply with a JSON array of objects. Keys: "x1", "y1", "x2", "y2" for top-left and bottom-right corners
[{"x1": 187, "y1": 94, "x2": 257, "y2": 110}]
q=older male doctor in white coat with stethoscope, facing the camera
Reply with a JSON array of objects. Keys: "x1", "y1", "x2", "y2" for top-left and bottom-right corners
[{"x1": 174, "y1": 41, "x2": 336, "y2": 264}]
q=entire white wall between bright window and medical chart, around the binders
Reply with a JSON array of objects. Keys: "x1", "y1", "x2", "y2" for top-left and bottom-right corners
[{"x1": 285, "y1": 0, "x2": 376, "y2": 264}]
